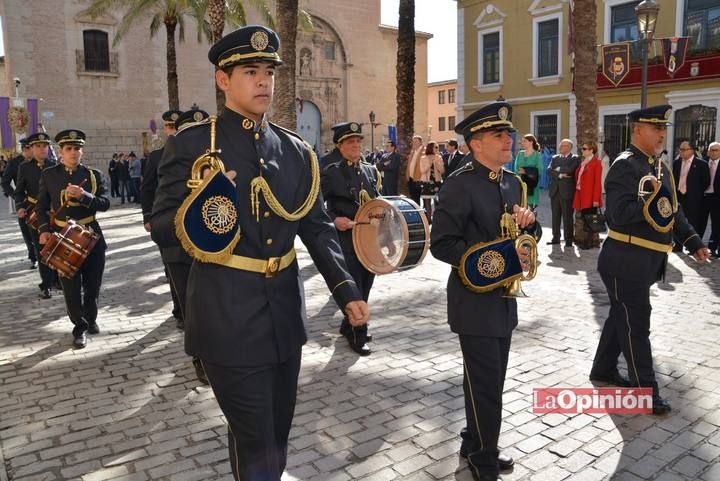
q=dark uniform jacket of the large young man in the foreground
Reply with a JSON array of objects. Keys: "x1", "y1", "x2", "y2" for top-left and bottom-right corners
[{"x1": 151, "y1": 107, "x2": 362, "y2": 366}]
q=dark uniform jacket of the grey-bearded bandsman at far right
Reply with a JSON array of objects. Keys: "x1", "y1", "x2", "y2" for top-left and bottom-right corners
[{"x1": 598, "y1": 145, "x2": 703, "y2": 284}]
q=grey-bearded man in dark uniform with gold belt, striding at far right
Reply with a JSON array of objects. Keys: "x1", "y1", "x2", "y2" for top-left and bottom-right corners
[{"x1": 590, "y1": 105, "x2": 710, "y2": 414}]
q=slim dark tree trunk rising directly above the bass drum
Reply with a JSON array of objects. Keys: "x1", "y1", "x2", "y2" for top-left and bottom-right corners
[{"x1": 396, "y1": 0, "x2": 415, "y2": 194}]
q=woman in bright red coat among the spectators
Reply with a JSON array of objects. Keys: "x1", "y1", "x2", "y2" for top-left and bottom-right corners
[{"x1": 573, "y1": 141, "x2": 602, "y2": 249}]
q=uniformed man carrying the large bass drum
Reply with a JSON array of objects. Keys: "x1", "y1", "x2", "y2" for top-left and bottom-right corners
[{"x1": 321, "y1": 122, "x2": 382, "y2": 356}]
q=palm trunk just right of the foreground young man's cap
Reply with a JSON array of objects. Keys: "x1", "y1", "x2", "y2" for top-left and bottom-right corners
[{"x1": 273, "y1": 0, "x2": 298, "y2": 130}]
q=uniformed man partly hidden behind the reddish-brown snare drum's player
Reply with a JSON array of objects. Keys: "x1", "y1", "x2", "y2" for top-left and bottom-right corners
[{"x1": 13, "y1": 132, "x2": 56, "y2": 299}]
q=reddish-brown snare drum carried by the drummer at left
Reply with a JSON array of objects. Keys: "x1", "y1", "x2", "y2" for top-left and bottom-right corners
[{"x1": 40, "y1": 219, "x2": 98, "y2": 279}]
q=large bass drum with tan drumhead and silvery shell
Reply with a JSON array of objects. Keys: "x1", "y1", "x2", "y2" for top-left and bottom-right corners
[{"x1": 352, "y1": 196, "x2": 430, "y2": 275}]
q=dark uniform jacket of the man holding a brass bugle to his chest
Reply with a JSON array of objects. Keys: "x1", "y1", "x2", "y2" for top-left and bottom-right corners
[{"x1": 430, "y1": 159, "x2": 541, "y2": 337}]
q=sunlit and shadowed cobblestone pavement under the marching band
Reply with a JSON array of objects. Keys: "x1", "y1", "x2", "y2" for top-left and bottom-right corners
[{"x1": 0, "y1": 192, "x2": 720, "y2": 481}]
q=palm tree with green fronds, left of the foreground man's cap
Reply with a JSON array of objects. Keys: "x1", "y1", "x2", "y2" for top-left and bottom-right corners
[{"x1": 83, "y1": 0, "x2": 211, "y2": 110}]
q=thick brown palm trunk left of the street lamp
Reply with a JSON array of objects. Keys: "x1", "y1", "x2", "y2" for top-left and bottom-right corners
[{"x1": 570, "y1": 0, "x2": 598, "y2": 147}]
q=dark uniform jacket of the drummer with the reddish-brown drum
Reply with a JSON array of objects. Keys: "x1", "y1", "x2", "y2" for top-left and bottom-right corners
[{"x1": 37, "y1": 164, "x2": 110, "y2": 250}]
